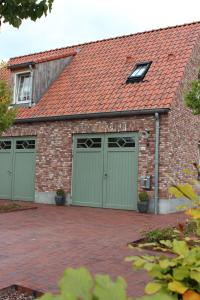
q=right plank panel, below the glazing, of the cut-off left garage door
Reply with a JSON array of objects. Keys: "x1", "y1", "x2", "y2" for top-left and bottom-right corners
[{"x1": 13, "y1": 152, "x2": 35, "y2": 201}]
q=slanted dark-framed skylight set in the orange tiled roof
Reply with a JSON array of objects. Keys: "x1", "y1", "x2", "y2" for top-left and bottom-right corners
[{"x1": 126, "y1": 61, "x2": 152, "y2": 83}]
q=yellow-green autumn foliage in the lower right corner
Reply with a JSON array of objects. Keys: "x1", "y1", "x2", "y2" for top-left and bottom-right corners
[{"x1": 126, "y1": 177, "x2": 200, "y2": 300}]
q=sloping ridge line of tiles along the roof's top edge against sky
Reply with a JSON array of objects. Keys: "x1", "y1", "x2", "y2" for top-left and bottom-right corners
[{"x1": 9, "y1": 21, "x2": 200, "y2": 60}]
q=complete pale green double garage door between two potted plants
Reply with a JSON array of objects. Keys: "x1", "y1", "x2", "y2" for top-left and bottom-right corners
[{"x1": 72, "y1": 133, "x2": 138, "y2": 210}]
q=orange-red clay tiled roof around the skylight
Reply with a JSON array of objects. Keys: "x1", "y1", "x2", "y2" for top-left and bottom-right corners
[{"x1": 5, "y1": 22, "x2": 200, "y2": 119}]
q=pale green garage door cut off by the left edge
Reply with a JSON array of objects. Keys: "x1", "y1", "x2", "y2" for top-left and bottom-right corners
[{"x1": 0, "y1": 137, "x2": 36, "y2": 201}]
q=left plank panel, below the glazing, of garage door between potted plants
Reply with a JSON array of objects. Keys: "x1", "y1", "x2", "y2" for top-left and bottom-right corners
[{"x1": 73, "y1": 151, "x2": 103, "y2": 207}]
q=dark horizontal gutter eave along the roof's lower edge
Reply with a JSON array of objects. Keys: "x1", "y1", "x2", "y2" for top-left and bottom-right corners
[{"x1": 14, "y1": 108, "x2": 170, "y2": 123}]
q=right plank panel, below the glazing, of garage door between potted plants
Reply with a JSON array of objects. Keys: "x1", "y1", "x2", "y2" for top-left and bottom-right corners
[{"x1": 104, "y1": 151, "x2": 137, "y2": 209}]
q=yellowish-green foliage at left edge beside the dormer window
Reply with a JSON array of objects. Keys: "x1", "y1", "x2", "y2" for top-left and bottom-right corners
[{"x1": 0, "y1": 80, "x2": 16, "y2": 135}]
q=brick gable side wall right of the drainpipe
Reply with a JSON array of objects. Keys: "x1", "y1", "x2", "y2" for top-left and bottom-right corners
[{"x1": 166, "y1": 39, "x2": 200, "y2": 196}]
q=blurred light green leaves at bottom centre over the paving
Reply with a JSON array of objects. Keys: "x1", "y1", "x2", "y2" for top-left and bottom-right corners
[{"x1": 40, "y1": 268, "x2": 132, "y2": 300}]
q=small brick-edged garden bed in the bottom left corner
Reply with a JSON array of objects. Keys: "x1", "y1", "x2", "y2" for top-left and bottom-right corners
[{"x1": 0, "y1": 285, "x2": 43, "y2": 300}]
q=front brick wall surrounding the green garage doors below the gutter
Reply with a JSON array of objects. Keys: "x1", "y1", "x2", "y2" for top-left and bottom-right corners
[{"x1": 5, "y1": 115, "x2": 162, "y2": 197}]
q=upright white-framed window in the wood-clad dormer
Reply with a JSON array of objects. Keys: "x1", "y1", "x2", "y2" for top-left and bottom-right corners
[{"x1": 17, "y1": 73, "x2": 31, "y2": 102}]
